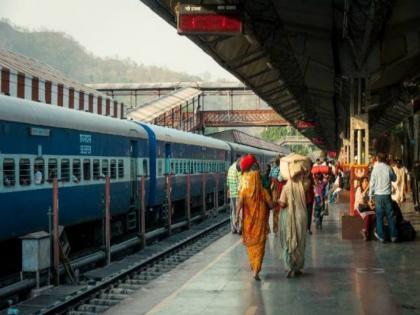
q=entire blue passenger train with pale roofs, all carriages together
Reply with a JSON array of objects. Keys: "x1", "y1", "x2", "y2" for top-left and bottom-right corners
[{"x1": 0, "y1": 96, "x2": 278, "y2": 249}]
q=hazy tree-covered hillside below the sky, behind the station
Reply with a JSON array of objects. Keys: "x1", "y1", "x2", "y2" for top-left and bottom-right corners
[{"x1": 0, "y1": 20, "x2": 200, "y2": 83}]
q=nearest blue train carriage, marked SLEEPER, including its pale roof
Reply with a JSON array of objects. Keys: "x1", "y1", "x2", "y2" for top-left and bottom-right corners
[{"x1": 0, "y1": 96, "x2": 148, "y2": 251}]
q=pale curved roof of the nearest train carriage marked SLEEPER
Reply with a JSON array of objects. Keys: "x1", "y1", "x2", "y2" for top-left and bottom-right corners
[{"x1": 0, "y1": 95, "x2": 148, "y2": 139}]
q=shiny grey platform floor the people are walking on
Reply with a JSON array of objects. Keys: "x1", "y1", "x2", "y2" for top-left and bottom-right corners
[{"x1": 108, "y1": 200, "x2": 420, "y2": 315}]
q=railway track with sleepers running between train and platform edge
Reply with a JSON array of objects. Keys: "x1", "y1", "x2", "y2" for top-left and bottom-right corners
[{"x1": 1, "y1": 214, "x2": 229, "y2": 315}]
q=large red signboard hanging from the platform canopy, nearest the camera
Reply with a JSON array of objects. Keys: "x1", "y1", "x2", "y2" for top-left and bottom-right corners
[{"x1": 177, "y1": 4, "x2": 243, "y2": 35}]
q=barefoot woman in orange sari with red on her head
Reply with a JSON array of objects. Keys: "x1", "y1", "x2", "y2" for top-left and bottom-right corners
[{"x1": 236, "y1": 154, "x2": 273, "y2": 280}]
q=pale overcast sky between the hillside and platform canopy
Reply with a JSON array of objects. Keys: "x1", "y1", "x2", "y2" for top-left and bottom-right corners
[{"x1": 0, "y1": 0, "x2": 237, "y2": 81}]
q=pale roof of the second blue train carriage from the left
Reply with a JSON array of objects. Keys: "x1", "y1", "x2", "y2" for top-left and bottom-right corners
[{"x1": 141, "y1": 122, "x2": 230, "y2": 151}]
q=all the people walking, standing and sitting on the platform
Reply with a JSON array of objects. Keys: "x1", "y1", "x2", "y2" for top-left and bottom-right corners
[{"x1": 227, "y1": 153, "x2": 418, "y2": 280}]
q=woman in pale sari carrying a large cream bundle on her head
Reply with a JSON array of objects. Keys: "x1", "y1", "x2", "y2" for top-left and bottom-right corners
[{"x1": 279, "y1": 154, "x2": 311, "y2": 278}]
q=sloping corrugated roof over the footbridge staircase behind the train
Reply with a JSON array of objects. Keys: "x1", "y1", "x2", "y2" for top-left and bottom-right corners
[{"x1": 127, "y1": 87, "x2": 202, "y2": 122}]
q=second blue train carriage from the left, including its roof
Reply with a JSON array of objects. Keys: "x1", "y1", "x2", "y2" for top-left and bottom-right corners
[{"x1": 141, "y1": 123, "x2": 230, "y2": 229}]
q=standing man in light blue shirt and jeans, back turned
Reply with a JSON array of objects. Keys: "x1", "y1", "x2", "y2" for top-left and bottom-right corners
[{"x1": 369, "y1": 153, "x2": 398, "y2": 242}]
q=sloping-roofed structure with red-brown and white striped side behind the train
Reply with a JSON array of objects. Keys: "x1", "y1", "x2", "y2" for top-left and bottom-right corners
[{"x1": 0, "y1": 50, "x2": 125, "y2": 118}]
